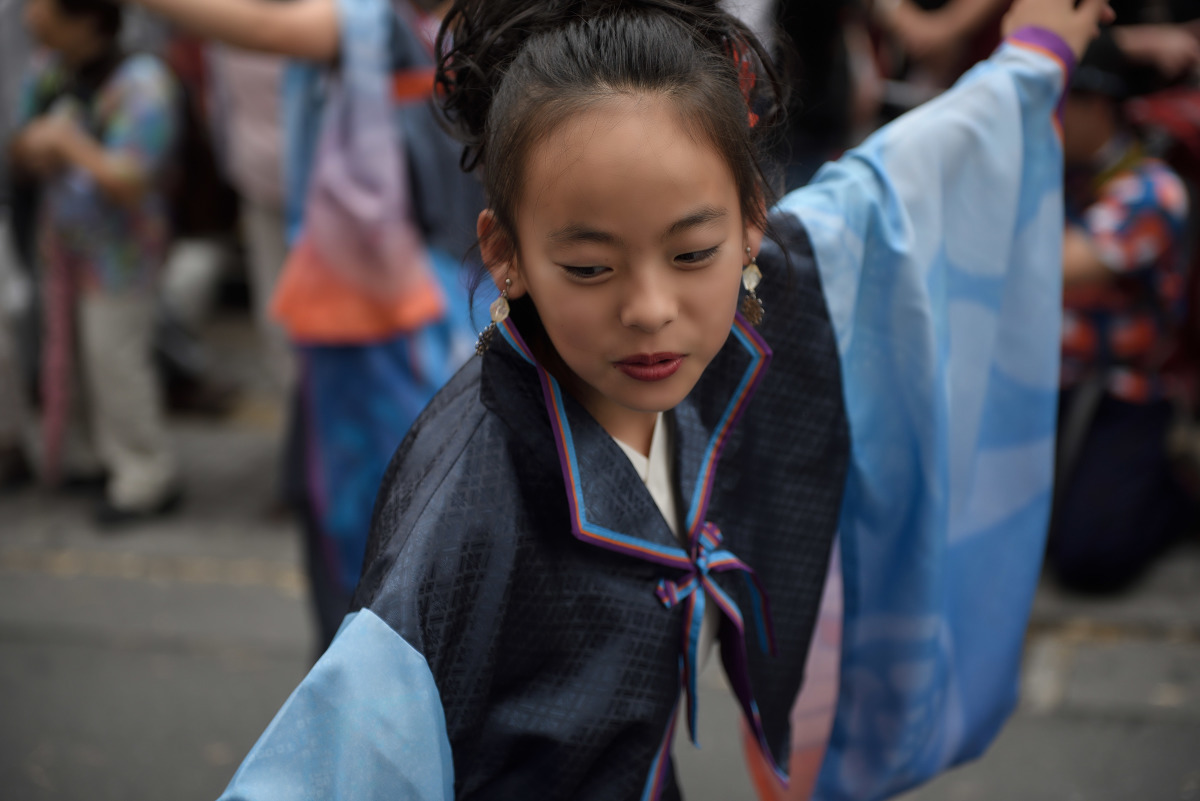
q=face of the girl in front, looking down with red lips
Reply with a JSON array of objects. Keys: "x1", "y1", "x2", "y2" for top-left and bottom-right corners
[{"x1": 480, "y1": 97, "x2": 762, "y2": 447}]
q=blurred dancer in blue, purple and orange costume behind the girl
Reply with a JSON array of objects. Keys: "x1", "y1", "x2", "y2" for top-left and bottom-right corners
[{"x1": 112, "y1": 0, "x2": 491, "y2": 651}]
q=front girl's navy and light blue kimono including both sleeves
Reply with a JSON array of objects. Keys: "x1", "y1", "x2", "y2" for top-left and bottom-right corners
[{"x1": 224, "y1": 30, "x2": 1070, "y2": 801}]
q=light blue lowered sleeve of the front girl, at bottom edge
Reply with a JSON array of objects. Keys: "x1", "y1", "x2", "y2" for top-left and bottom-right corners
[{"x1": 221, "y1": 610, "x2": 454, "y2": 801}]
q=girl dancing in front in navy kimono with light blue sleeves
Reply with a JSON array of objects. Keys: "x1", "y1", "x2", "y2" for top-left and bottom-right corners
[{"x1": 211, "y1": 0, "x2": 1109, "y2": 800}]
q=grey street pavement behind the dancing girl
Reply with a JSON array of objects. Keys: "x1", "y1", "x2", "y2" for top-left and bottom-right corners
[{"x1": 0, "y1": 309, "x2": 1200, "y2": 801}]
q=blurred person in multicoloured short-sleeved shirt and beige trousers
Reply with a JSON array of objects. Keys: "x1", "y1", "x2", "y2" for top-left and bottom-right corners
[{"x1": 8, "y1": 0, "x2": 180, "y2": 525}]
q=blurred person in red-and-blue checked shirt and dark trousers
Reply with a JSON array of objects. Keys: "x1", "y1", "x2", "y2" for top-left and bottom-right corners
[{"x1": 1048, "y1": 38, "x2": 1193, "y2": 591}]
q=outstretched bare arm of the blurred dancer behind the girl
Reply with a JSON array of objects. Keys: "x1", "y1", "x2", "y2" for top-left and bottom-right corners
[{"x1": 125, "y1": 0, "x2": 340, "y2": 61}]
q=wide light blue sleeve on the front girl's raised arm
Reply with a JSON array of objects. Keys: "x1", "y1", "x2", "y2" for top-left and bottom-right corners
[{"x1": 781, "y1": 29, "x2": 1074, "y2": 801}]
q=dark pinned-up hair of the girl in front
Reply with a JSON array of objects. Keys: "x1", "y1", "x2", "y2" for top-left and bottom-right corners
[{"x1": 437, "y1": 0, "x2": 786, "y2": 270}]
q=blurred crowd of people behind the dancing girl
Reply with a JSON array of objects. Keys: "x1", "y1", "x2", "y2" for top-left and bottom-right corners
[{"x1": 0, "y1": 0, "x2": 1200, "y2": 644}]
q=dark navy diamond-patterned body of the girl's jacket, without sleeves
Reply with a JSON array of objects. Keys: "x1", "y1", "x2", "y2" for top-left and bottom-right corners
[{"x1": 355, "y1": 218, "x2": 848, "y2": 801}]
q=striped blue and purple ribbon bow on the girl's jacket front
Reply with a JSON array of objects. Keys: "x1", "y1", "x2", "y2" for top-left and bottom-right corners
[{"x1": 655, "y1": 520, "x2": 775, "y2": 746}]
